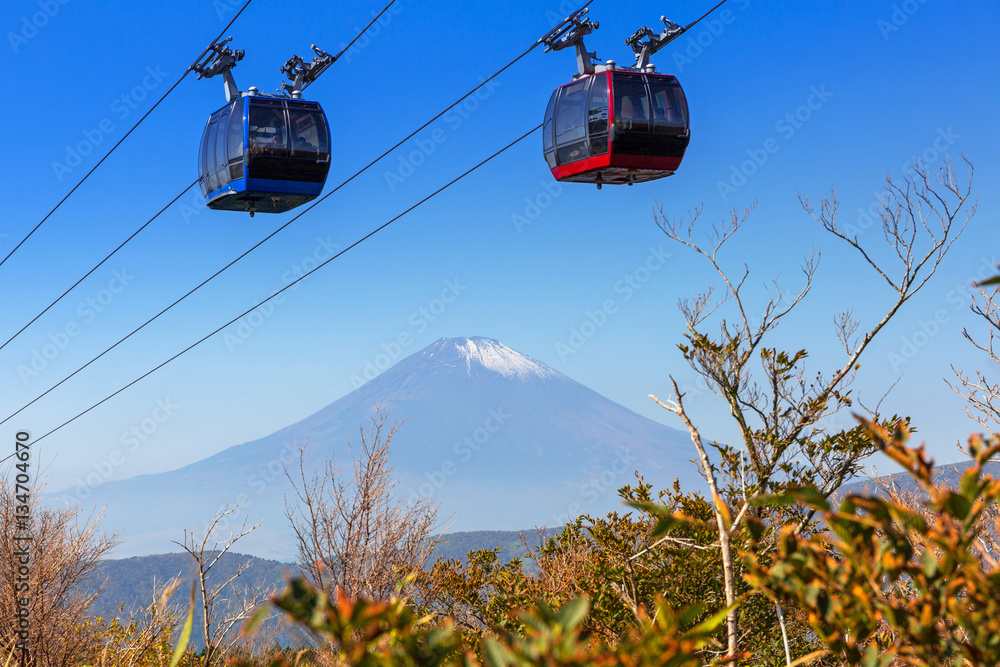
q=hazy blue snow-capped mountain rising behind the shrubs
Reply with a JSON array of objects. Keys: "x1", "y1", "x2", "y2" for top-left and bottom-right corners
[{"x1": 56, "y1": 337, "x2": 702, "y2": 560}]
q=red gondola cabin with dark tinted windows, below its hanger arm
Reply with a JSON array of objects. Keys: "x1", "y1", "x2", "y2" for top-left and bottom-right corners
[{"x1": 542, "y1": 70, "x2": 691, "y2": 187}]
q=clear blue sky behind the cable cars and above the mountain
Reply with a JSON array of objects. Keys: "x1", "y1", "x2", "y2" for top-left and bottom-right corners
[{"x1": 0, "y1": 0, "x2": 1000, "y2": 489}]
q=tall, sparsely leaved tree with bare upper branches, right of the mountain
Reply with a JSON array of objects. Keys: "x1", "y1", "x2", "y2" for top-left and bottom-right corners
[{"x1": 653, "y1": 160, "x2": 972, "y2": 662}]
